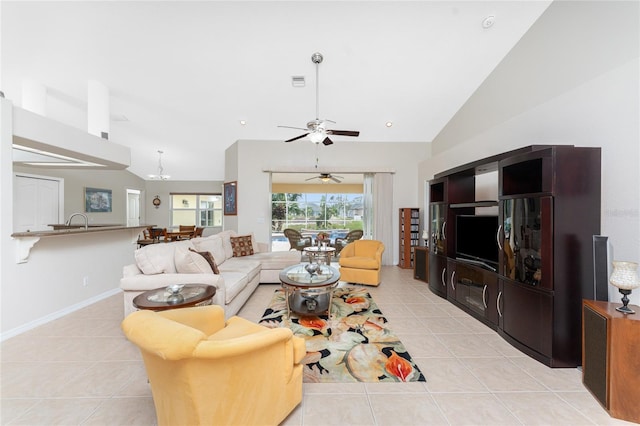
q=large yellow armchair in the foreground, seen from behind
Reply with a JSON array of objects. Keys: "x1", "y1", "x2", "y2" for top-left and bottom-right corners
[{"x1": 122, "y1": 305, "x2": 306, "y2": 425}]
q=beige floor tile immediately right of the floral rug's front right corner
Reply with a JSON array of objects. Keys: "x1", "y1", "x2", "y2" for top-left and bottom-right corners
[{"x1": 422, "y1": 358, "x2": 488, "y2": 392}]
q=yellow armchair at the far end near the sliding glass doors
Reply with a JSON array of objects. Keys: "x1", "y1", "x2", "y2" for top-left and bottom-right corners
[{"x1": 339, "y1": 240, "x2": 384, "y2": 286}]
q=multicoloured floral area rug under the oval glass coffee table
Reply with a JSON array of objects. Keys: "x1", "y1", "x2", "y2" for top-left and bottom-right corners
[{"x1": 260, "y1": 288, "x2": 426, "y2": 383}]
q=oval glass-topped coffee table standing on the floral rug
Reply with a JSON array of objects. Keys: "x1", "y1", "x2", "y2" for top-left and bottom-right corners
[{"x1": 280, "y1": 263, "x2": 340, "y2": 318}]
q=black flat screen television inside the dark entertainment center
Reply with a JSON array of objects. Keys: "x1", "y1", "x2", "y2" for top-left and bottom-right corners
[{"x1": 456, "y1": 215, "x2": 499, "y2": 271}]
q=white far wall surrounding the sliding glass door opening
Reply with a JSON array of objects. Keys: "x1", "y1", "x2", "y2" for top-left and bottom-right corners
[{"x1": 225, "y1": 140, "x2": 428, "y2": 264}]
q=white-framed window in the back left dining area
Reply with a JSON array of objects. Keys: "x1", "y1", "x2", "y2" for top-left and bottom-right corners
[{"x1": 171, "y1": 194, "x2": 222, "y2": 227}]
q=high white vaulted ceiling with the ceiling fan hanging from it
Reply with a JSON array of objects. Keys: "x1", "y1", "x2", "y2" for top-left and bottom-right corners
[{"x1": 0, "y1": 0, "x2": 550, "y2": 180}]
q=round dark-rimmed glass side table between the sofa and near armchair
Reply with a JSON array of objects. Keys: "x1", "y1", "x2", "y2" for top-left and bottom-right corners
[{"x1": 133, "y1": 284, "x2": 216, "y2": 311}]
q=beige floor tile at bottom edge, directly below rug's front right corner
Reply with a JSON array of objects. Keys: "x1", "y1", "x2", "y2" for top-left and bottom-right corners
[{"x1": 369, "y1": 394, "x2": 446, "y2": 426}]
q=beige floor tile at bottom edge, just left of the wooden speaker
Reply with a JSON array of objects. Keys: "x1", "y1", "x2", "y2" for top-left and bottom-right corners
[{"x1": 496, "y1": 392, "x2": 594, "y2": 425}]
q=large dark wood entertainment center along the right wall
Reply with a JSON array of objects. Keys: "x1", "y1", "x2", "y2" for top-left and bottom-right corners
[{"x1": 428, "y1": 145, "x2": 601, "y2": 367}]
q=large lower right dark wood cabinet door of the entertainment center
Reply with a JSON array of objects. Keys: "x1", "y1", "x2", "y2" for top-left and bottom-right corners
[{"x1": 498, "y1": 279, "x2": 553, "y2": 358}]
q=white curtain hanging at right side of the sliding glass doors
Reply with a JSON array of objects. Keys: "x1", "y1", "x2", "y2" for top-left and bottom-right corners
[{"x1": 373, "y1": 173, "x2": 394, "y2": 265}]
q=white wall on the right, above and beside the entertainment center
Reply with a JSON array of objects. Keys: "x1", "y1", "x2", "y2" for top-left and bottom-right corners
[{"x1": 420, "y1": 2, "x2": 640, "y2": 305}]
